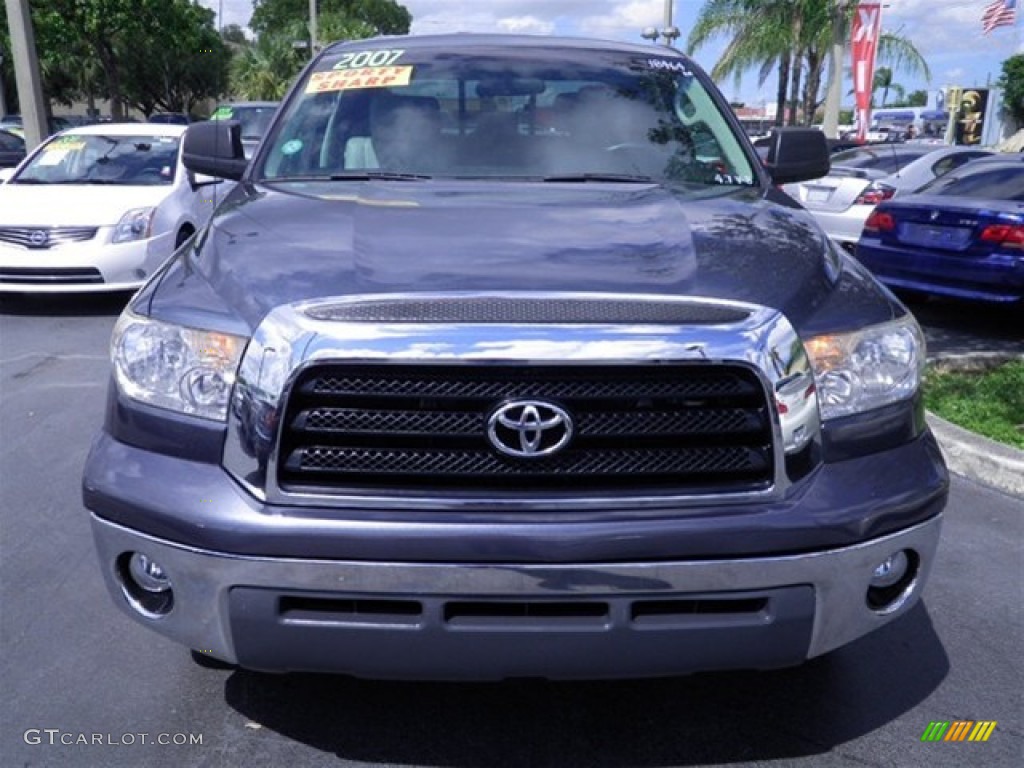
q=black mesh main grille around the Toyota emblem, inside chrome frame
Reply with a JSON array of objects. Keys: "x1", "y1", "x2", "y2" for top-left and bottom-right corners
[{"x1": 278, "y1": 362, "x2": 774, "y2": 494}]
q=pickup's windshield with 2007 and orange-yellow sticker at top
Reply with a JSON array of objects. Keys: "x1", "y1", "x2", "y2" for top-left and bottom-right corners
[{"x1": 257, "y1": 43, "x2": 758, "y2": 186}]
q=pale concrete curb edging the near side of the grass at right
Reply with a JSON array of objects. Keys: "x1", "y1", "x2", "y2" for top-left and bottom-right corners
[{"x1": 928, "y1": 412, "x2": 1024, "y2": 499}]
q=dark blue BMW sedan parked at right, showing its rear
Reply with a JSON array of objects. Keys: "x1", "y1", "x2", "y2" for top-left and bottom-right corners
[{"x1": 857, "y1": 154, "x2": 1024, "y2": 303}]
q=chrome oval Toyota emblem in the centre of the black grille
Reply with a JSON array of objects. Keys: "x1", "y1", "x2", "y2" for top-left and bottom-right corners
[{"x1": 487, "y1": 400, "x2": 572, "y2": 459}]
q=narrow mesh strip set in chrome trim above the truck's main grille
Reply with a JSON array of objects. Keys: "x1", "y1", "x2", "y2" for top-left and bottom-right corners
[{"x1": 306, "y1": 296, "x2": 749, "y2": 325}]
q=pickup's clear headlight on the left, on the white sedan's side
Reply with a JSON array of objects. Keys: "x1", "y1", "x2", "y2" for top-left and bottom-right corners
[{"x1": 111, "y1": 310, "x2": 246, "y2": 421}]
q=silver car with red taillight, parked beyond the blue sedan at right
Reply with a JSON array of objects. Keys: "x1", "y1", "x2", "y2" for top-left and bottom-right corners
[{"x1": 782, "y1": 143, "x2": 992, "y2": 253}]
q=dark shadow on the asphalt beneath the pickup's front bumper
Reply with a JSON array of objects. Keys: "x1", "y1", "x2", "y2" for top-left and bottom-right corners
[{"x1": 225, "y1": 604, "x2": 949, "y2": 768}]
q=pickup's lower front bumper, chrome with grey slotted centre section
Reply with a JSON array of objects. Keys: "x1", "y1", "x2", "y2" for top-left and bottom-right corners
[{"x1": 92, "y1": 515, "x2": 941, "y2": 680}]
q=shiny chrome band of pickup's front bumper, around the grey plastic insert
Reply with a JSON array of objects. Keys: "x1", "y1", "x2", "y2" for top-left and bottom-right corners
[{"x1": 92, "y1": 515, "x2": 942, "y2": 678}]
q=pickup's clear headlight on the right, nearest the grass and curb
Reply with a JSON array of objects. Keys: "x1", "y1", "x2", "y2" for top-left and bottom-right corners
[{"x1": 805, "y1": 314, "x2": 925, "y2": 419}]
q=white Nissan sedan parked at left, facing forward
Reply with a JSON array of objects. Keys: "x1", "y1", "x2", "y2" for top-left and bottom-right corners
[{"x1": 0, "y1": 123, "x2": 218, "y2": 293}]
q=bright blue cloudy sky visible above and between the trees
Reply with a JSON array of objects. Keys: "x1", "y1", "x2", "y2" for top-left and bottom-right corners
[{"x1": 200, "y1": 0, "x2": 1024, "y2": 106}]
